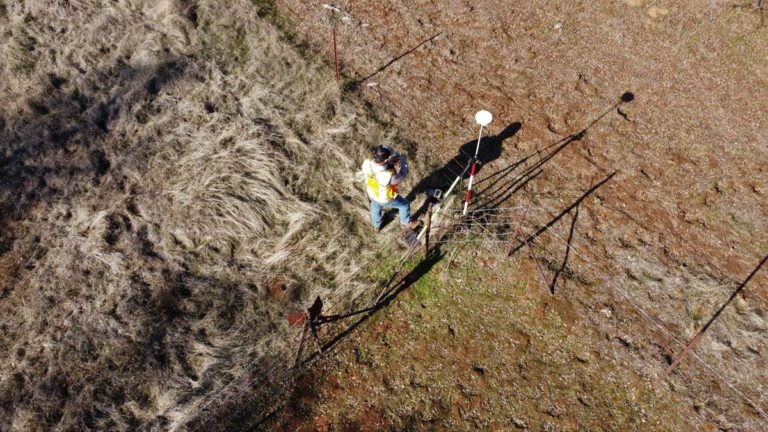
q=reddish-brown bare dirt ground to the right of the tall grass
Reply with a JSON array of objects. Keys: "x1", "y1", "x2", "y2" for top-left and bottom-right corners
[{"x1": 270, "y1": 0, "x2": 768, "y2": 430}]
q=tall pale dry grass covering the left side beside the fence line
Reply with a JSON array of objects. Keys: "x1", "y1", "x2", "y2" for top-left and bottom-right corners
[{"x1": 0, "y1": 0, "x2": 426, "y2": 431}]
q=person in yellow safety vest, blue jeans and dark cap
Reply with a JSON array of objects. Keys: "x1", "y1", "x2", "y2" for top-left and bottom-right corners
[{"x1": 362, "y1": 145, "x2": 421, "y2": 231}]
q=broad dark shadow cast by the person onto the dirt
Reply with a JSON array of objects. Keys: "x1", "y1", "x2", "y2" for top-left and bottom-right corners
[{"x1": 406, "y1": 122, "x2": 523, "y2": 218}]
